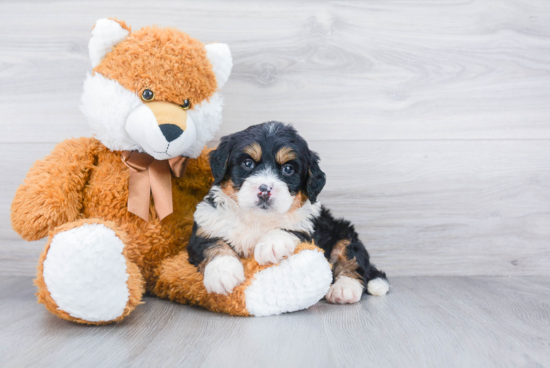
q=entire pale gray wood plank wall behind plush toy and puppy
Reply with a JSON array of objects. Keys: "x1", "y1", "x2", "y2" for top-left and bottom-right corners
[{"x1": 0, "y1": 0, "x2": 550, "y2": 277}]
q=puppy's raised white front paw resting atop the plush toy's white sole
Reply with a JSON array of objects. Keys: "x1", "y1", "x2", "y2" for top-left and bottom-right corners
[{"x1": 254, "y1": 230, "x2": 300, "y2": 265}]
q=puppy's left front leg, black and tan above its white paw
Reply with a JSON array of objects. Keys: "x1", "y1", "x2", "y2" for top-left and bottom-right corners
[{"x1": 187, "y1": 225, "x2": 245, "y2": 295}]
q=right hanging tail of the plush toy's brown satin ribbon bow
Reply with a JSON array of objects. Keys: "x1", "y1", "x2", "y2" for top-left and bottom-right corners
[{"x1": 149, "y1": 160, "x2": 174, "y2": 221}]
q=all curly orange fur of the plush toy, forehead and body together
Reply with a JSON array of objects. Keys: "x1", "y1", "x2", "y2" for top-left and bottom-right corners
[{"x1": 11, "y1": 23, "x2": 328, "y2": 324}]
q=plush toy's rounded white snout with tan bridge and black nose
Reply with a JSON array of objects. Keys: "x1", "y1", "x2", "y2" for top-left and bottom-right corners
[{"x1": 126, "y1": 101, "x2": 197, "y2": 160}]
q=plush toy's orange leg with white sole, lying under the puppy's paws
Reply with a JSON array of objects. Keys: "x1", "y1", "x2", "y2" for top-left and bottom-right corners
[{"x1": 155, "y1": 243, "x2": 332, "y2": 316}]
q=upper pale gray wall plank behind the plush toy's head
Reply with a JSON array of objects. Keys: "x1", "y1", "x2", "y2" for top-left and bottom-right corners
[{"x1": 0, "y1": 0, "x2": 550, "y2": 142}]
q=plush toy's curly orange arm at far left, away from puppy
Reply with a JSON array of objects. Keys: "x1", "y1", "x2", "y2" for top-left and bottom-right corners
[{"x1": 11, "y1": 138, "x2": 96, "y2": 241}]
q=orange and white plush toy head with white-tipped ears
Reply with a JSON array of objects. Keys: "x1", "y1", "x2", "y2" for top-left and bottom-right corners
[{"x1": 81, "y1": 19, "x2": 233, "y2": 160}]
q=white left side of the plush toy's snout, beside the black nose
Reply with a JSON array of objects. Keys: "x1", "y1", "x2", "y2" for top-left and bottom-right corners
[{"x1": 126, "y1": 104, "x2": 168, "y2": 160}]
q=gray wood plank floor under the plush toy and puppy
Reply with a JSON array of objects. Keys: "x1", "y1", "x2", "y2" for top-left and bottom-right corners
[{"x1": 0, "y1": 277, "x2": 550, "y2": 368}]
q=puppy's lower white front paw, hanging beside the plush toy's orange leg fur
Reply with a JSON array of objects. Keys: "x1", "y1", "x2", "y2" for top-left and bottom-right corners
[{"x1": 204, "y1": 256, "x2": 245, "y2": 295}]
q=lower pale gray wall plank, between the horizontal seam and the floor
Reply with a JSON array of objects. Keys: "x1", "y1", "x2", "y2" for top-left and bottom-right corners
[{"x1": 0, "y1": 141, "x2": 550, "y2": 276}]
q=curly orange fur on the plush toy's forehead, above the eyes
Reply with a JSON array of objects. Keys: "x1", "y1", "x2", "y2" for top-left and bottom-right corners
[{"x1": 94, "y1": 26, "x2": 217, "y2": 108}]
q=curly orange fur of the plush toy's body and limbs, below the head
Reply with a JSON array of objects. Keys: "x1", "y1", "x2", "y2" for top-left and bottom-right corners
[{"x1": 11, "y1": 138, "x2": 328, "y2": 324}]
